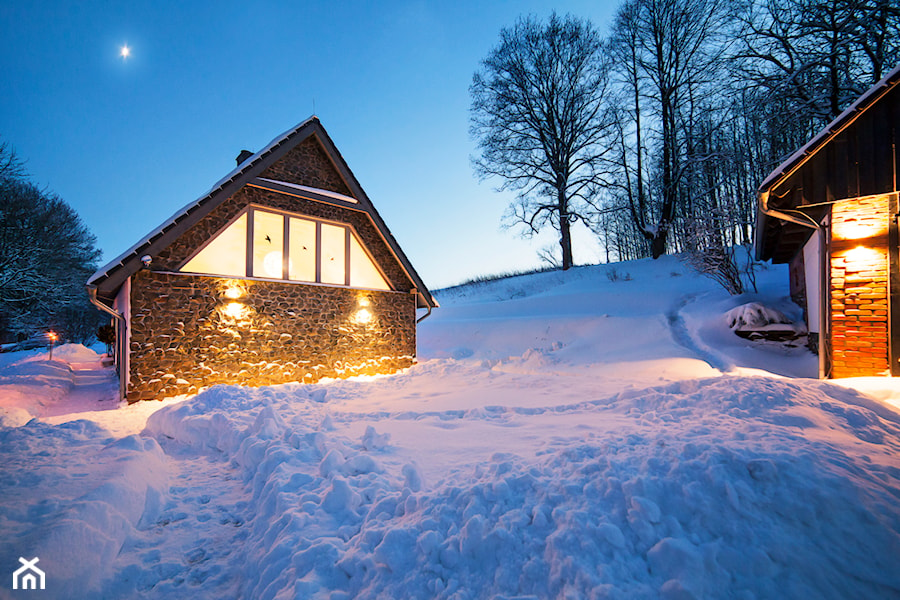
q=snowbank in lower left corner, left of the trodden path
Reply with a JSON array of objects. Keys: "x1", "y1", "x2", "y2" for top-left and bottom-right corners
[{"x1": 0, "y1": 420, "x2": 168, "y2": 599}]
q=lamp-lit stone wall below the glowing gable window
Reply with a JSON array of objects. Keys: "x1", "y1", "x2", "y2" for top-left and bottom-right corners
[{"x1": 126, "y1": 270, "x2": 416, "y2": 402}]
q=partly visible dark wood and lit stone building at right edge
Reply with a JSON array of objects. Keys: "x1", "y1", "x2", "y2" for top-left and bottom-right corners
[{"x1": 756, "y1": 66, "x2": 900, "y2": 378}]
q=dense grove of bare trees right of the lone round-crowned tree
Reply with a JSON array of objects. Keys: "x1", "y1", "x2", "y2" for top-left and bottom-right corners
[{"x1": 594, "y1": 0, "x2": 900, "y2": 268}]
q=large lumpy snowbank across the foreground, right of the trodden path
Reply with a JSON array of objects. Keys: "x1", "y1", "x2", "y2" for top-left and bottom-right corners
[{"x1": 130, "y1": 377, "x2": 900, "y2": 598}]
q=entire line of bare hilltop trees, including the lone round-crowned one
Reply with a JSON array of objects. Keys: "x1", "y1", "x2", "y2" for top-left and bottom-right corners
[{"x1": 470, "y1": 0, "x2": 900, "y2": 268}]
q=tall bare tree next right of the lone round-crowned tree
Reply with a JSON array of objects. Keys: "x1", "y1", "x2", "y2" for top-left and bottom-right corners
[{"x1": 612, "y1": 0, "x2": 725, "y2": 258}]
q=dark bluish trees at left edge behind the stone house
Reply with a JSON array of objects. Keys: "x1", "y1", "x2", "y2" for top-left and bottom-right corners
[{"x1": 0, "y1": 143, "x2": 105, "y2": 343}]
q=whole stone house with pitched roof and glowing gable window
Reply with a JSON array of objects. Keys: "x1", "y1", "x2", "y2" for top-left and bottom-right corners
[{"x1": 87, "y1": 117, "x2": 437, "y2": 402}]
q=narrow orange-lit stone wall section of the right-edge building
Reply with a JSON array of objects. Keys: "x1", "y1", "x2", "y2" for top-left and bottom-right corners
[{"x1": 831, "y1": 196, "x2": 890, "y2": 377}]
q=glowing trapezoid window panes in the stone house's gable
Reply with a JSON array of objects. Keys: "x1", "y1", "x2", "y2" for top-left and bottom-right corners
[{"x1": 181, "y1": 208, "x2": 391, "y2": 290}]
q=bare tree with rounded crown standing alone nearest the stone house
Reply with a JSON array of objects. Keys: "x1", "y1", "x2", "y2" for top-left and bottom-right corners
[{"x1": 470, "y1": 13, "x2": 608, "y2": 269}]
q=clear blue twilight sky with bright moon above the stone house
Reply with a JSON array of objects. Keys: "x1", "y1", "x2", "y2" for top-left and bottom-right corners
[{"x1": 0, "y1": 0, "x2": 617, "y2": 288}]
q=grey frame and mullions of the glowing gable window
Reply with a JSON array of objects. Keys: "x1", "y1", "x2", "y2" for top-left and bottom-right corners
[{"x1": 177, "y1": 204, "x2": 395, "y2": 291}]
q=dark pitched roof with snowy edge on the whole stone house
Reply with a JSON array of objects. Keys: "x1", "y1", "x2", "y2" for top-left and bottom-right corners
[{"x1": 87, "y1": 116, "x2": 438, "y2": 308}]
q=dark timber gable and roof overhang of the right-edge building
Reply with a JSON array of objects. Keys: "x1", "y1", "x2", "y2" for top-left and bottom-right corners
[{"x1": 755, "y1": 65, "x2": 900, "y2": 262}]
